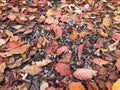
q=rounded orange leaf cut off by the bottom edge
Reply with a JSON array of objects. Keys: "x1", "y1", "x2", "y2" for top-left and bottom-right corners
[{"x1": 68, "y1": 82, "x2": 85, "y2": 90}]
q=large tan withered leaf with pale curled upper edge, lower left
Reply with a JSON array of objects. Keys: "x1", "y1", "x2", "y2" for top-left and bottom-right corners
[{"x1": 21, "y1": 59, "x2": 51, "y2": 75}]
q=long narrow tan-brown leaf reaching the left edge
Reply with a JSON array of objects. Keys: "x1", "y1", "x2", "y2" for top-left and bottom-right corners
[{"x1": 0, "y1": 44, "x2": 30, "y2": 57}]
